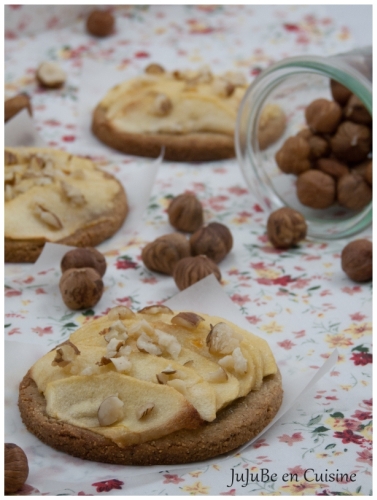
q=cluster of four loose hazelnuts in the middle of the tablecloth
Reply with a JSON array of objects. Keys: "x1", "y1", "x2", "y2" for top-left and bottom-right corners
[{"x1": 141, "y1": 192, "x2": 233, "y2": 290}]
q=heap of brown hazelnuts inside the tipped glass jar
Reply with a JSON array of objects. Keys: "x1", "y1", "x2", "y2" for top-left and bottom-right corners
[{"x1": 275, "y1": 80, "x2": 372, "y2": 210}]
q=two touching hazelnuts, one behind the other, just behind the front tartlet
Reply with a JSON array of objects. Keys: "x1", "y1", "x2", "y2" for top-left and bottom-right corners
[{"x1": 59, "y1": 247, "x2": 107, "y2": 310}]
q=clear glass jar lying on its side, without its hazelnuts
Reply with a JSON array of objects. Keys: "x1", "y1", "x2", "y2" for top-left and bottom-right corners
[{"x1": 235, "y1": 47, "x2": 373, "y2": 239}]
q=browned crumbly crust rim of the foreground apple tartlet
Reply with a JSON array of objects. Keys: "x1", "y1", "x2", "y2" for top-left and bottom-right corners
[{"x1": 18, "y1": 373, "x2": 283, "y2": 465}]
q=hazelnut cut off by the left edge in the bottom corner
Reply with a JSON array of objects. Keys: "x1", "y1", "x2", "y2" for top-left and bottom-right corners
[{"x1": 4, "y1": 443, "x2": 29, "y2": 495}]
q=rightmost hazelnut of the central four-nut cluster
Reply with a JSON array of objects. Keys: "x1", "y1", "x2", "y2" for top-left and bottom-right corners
[{"x1": 190, "y1": 222, "x2": 233, "y2": 263}]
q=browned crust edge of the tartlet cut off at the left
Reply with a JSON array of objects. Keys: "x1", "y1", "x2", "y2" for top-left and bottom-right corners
[{"x1": 4, "y1": 172, "x2": 128, "y2": 262}]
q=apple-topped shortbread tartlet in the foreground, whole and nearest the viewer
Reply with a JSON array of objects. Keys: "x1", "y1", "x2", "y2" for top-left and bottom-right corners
[{"x1": 19, "y1": 305, "x2": 283, "y2": 465}]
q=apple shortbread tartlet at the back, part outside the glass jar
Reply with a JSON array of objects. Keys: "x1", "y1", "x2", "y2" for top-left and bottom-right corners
[{"x1": 92, "y1": 64, "x2": 247, "y2": 161}]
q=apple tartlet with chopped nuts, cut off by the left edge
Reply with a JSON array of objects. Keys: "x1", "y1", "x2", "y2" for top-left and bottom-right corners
[{"x1": 4, "y1": 148, "x2": 128, "y2": 262}]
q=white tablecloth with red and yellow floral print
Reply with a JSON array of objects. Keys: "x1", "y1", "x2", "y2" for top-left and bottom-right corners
[{"x1": 4, "y1": 5, "x2": 372, "y2": 495}]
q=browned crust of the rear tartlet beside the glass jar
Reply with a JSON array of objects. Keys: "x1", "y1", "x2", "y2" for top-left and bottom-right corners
[{"x1": 92, "y1": 104, "x2": 235, "y2": 162}]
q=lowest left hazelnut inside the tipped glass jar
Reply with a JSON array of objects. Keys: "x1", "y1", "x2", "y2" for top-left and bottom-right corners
[{"x1": 296, "y1": 170, "x2": 336, "y2": 209}]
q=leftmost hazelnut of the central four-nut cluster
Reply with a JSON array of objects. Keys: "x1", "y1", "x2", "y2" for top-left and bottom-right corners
[{"x1": 141, "y1": 233, "x2": 191, "y2": 276}]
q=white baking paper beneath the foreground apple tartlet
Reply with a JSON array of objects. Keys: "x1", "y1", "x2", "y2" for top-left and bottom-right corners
[{"x1": 5, "y1": 274, "x2": 338, "y2": 491}]
